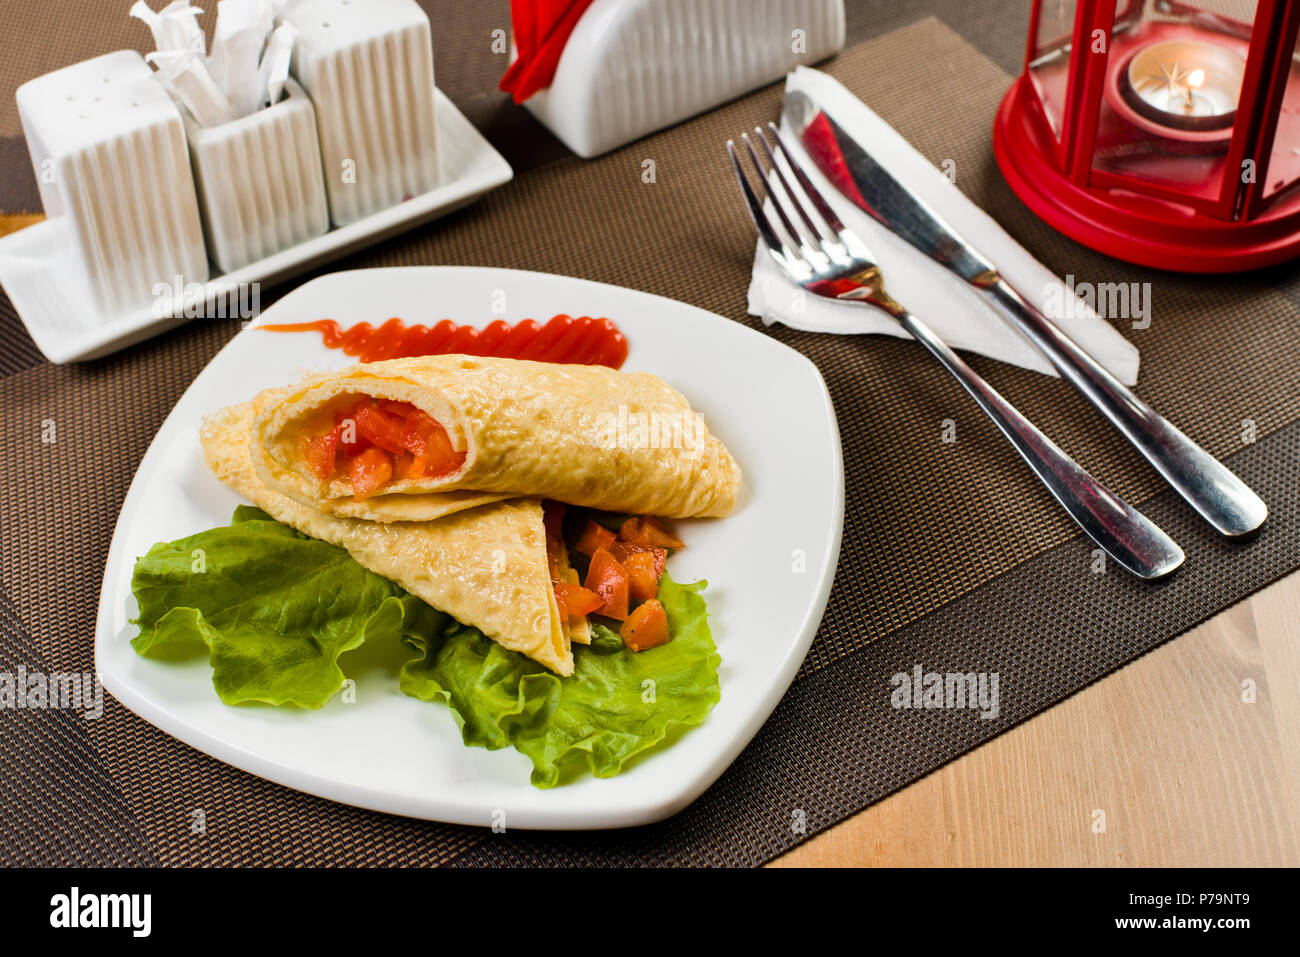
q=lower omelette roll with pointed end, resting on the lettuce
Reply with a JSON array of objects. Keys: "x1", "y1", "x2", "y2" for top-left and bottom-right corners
[{"x1": 200, "y1": 403, "x2": 573, "y2": 675}]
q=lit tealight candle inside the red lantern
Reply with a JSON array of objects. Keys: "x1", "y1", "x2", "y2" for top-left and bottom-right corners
[{"x1": 1126, "y1": 40, "x2": 1245, "y2": 130}]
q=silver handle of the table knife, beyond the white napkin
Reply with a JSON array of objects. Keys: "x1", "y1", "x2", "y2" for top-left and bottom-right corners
[{"x1": 976, "y1": 278, "x2": 1269, "y2": 538}]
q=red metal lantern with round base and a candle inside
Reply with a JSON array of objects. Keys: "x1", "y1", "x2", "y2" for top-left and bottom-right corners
[{"x1": 993, "y1": 0, "x2": 1300, "y2": 272}]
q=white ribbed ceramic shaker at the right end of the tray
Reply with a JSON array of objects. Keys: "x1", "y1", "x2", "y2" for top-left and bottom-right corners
[{"x1": 281, "y1": 0, "x2": 439, "y2": 226}]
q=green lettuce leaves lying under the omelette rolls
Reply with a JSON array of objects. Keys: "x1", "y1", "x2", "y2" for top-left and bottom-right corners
[{"x1": 131, "y1": 506, "x2": 719, "y2": 788}]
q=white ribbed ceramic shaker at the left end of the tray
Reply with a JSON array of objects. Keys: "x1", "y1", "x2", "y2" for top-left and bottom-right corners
[{"x1": 17, "y1": 49, "x2": 208, "y2": 319}]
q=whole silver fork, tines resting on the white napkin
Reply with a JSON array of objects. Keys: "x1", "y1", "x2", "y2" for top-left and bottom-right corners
[{"x1": 727, "y1": 124, "x2": 1183, "y2": 579}]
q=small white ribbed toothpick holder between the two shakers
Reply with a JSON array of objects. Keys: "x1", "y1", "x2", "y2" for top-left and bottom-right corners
[{"x1": 185, "y1": 79, "x2": 329, "y2": 273}]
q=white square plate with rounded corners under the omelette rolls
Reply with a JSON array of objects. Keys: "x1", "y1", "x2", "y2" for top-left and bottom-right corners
[{"x1": 95, "y1": 267, "x2": 844, "y2": 828}]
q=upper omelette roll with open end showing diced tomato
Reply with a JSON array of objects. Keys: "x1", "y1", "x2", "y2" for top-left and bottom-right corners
[{"x1": 254, "y1": 355, "x2": 741, "y2": 521}]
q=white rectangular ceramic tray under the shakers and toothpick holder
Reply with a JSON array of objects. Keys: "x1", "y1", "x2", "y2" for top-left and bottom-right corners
[{"x1": 0, "y1": 90, "x2": 514, "y2": 363}]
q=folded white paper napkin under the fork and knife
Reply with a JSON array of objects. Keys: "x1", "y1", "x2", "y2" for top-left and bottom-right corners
[{"x1": 749, "y1": 66, "x2": 1138, "y2": 385}]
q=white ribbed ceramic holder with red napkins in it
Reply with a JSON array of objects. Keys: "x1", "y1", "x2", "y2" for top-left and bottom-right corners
[{"x1": 524, "y1": 0, "x2": 845, "y2": 159}]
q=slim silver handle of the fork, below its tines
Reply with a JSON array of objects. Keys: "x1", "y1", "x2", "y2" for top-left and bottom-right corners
[{"x1": 893, "y1": 308, "x2": 1183, "y2": 579}]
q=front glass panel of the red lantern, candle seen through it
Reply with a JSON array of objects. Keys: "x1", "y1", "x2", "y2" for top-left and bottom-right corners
[{"x1": 1092, "y1": 0, "x2": 1255, "y2": 204}]
